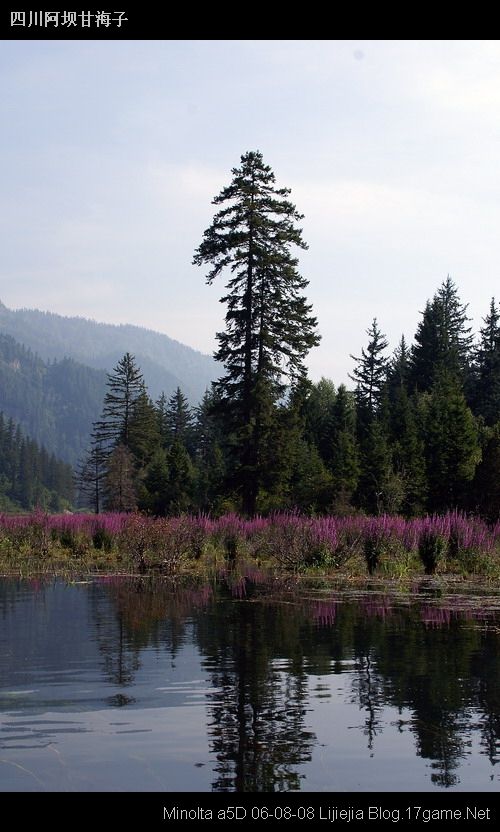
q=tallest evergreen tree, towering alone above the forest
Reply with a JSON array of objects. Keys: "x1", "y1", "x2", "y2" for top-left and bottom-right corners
[{"x1": 194, "y1": 152, "x2": 319, "y2": 514}]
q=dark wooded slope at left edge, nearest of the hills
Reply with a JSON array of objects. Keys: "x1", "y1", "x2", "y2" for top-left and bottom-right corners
[{"x1": 0, "y1": 411, "x2": 74, "y2": 511}]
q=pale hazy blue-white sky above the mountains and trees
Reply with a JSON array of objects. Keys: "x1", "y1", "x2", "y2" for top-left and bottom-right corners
[{"x1": 0, "y1": 41, "x2": 500, "y2": 383}]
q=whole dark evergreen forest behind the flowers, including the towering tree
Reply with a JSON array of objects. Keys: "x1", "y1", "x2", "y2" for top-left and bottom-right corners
[{"x1": 75, "y1": 151, "x2": 500, "y2": 521}]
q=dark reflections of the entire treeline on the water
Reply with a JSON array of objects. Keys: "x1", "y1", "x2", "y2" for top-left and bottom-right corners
[{"x1": 93, "y1": 579, "x2": 500, "y2": 792}]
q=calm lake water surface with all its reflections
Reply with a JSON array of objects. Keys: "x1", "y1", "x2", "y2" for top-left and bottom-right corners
[{"x1": 0, "y1": 578, "x2": 500, "y2": 792}]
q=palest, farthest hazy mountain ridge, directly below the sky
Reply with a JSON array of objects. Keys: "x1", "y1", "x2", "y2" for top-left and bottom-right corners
[{"x1": 0, "y1": 301, "x2": 221, "y2": 405}]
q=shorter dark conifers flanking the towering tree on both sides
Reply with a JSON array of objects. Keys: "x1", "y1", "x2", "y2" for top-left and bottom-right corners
[{"x1": 80, "y1": 277, "x2": 500, "y2": 520}]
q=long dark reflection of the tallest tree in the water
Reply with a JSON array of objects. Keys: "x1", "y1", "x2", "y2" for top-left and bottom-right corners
[{"x1": 197, "y1": 601, "x2": 316, "y2": 792}]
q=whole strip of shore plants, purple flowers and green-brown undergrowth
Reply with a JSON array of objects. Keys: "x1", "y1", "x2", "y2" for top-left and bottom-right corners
[{"x1": 0, "y1": 510, "x2": 500, "y2": 583}]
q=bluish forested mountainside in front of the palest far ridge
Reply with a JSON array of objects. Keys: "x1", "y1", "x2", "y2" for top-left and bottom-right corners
[{"x1": 0, "y1": 332, "x2": 106, "y2": 465}]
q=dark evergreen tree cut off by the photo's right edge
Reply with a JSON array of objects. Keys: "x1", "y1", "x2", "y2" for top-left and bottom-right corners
[{"x1": 473, "y1": 298, "x2": 500, "y2": 425}]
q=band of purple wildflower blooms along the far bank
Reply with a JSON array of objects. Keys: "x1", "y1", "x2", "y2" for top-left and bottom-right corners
[{"x1": 0, "y1": 504, "x2": 500, "y2": 574}]
